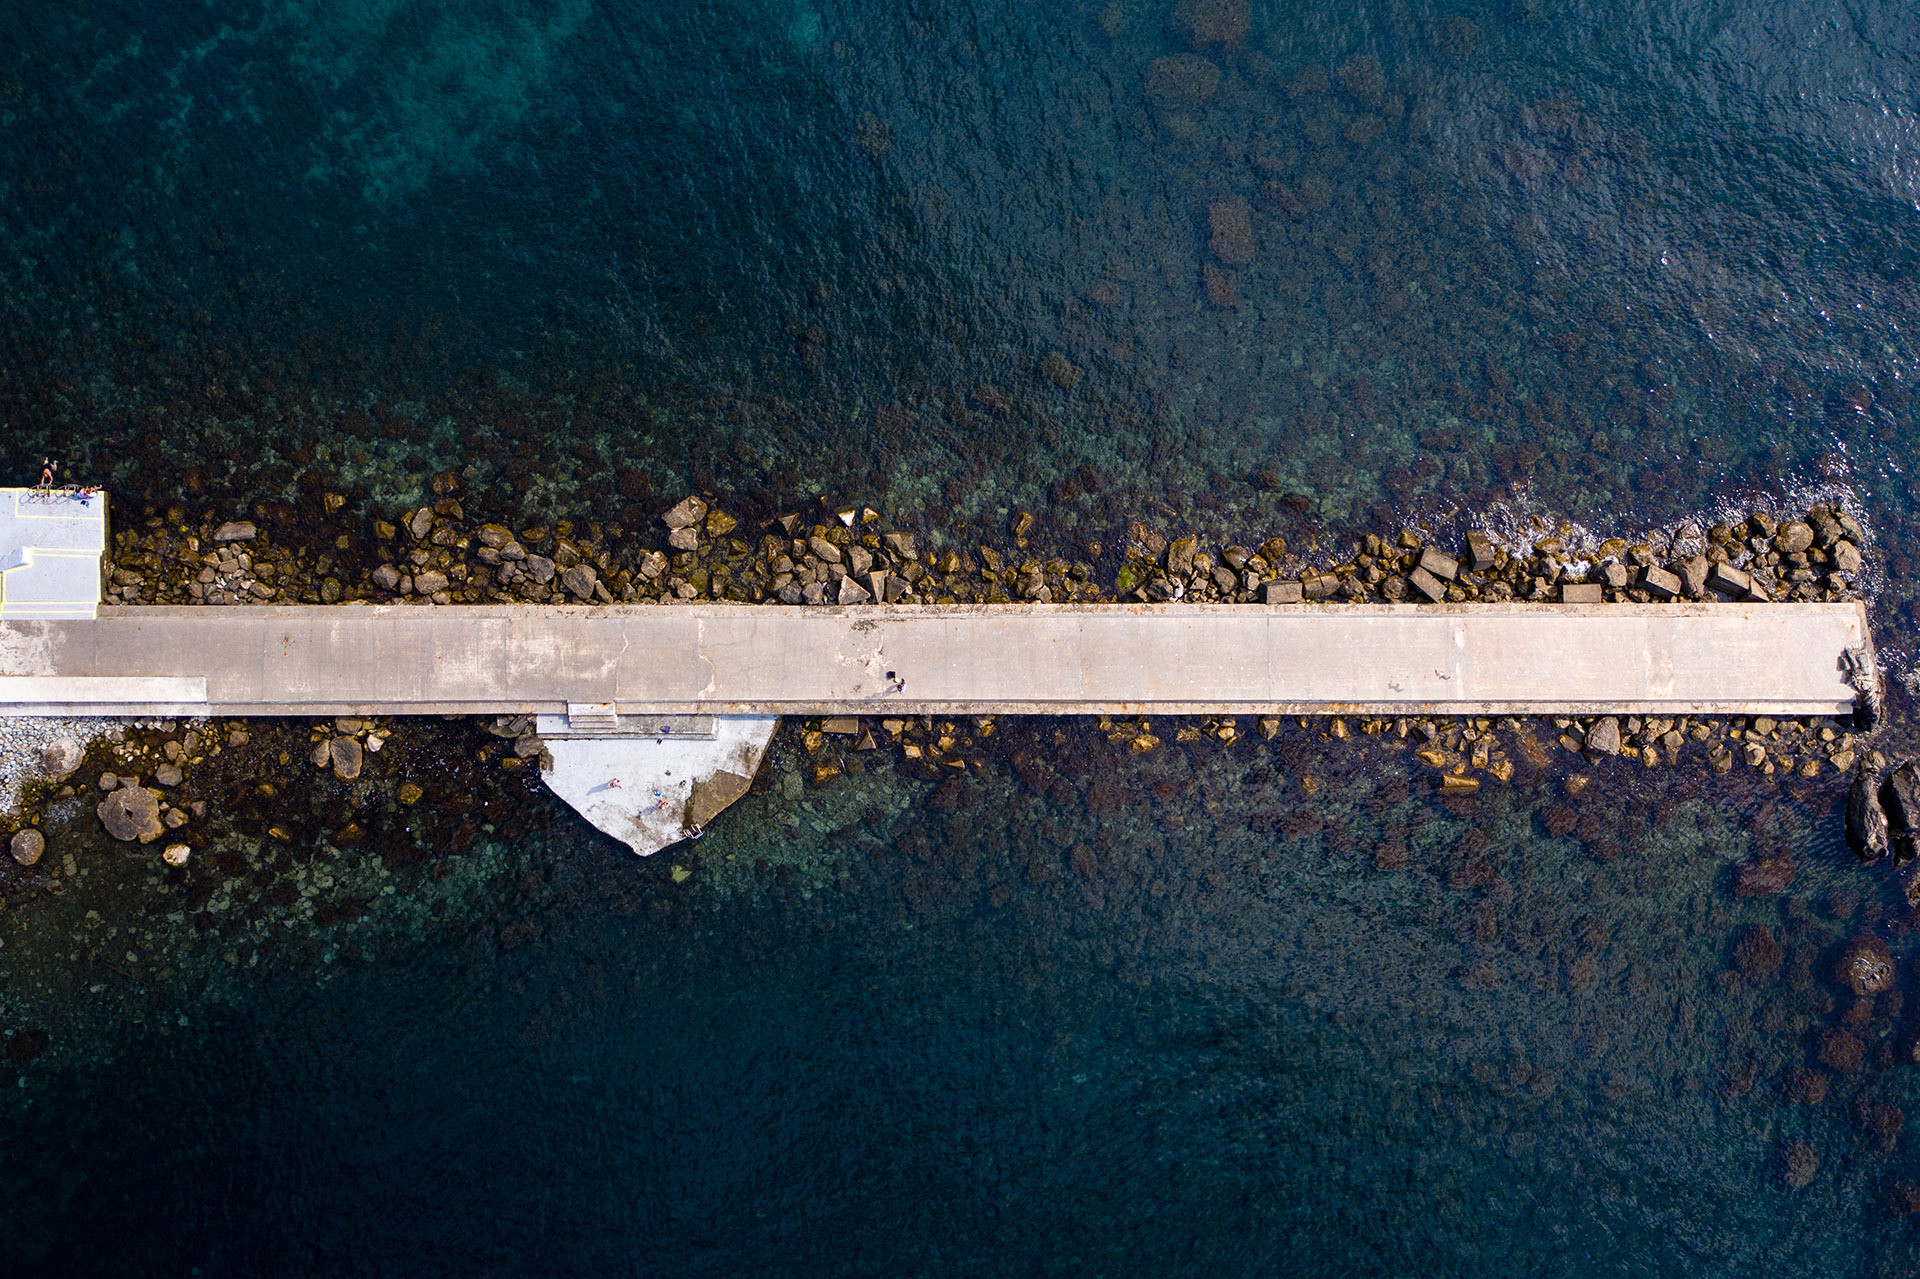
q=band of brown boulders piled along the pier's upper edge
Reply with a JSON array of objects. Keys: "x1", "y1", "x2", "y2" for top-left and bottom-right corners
[{"x1": 93, "y1": 472, "x2": 1866, "y2": 605}]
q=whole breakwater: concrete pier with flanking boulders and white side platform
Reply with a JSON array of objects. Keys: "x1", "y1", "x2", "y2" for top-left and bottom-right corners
[{"x1": 0, "y1": 476, "x2": 1878, "y2": 851}]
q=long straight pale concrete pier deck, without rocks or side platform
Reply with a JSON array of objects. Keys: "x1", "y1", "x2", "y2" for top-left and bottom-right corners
[{"x1": 0, "y1": 603, "x2": 1872, "y2": 716}]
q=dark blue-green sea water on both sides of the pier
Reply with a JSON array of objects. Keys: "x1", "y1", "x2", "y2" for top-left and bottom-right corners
[{"x1": 0, "y1": 0, "x2": 1920, "y2": 1275}]
